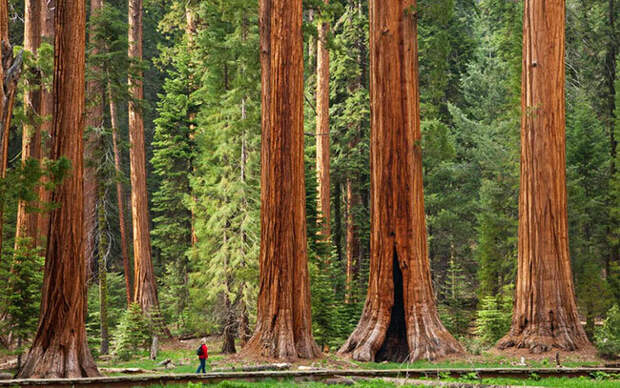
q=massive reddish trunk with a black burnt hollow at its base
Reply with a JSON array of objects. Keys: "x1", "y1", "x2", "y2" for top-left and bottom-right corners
[{"x1": 340, "y1": 0, "x2": 463, "y2": 362}]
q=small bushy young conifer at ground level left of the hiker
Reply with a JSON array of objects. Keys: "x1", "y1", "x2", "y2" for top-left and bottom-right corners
[{"x1": 110, "y1": 303, "x2": 153, "y2": 360}]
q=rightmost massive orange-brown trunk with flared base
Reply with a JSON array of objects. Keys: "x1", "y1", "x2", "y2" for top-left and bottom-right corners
[{"x1": 498, "y1": 0, "x2": 588, "y2": 353}]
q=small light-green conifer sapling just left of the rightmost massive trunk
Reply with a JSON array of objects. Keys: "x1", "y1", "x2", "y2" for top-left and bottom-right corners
[{"x1": 476, "y1": 292, "x2": 512, "y2": 345}]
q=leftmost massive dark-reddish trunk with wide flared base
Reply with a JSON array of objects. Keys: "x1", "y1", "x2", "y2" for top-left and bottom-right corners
[{"x1": 18, "y1": 0, "x2": 99, "y2": 378}]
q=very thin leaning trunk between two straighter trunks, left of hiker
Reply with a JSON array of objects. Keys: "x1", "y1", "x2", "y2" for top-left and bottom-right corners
[{"x1": 108, "y1": 77, "x2": 131, "y2": 307}]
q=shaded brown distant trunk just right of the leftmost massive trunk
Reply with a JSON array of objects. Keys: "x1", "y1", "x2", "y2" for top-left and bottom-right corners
[{"x1": 84, "y1": 0, "x2": 104, "y2": 281}]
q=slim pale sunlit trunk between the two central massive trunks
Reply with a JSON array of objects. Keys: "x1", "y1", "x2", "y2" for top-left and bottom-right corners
[{"x1": 316, "y1": 0, "x2": 331, "y2": 241}]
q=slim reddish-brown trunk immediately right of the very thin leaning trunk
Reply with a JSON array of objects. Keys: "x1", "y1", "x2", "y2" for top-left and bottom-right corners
[{"x1": 129, "y1": 0, "x2": 159, "y2": 314}]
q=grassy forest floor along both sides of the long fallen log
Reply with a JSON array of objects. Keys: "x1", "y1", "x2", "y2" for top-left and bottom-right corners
[{"x1": 0, "y1": 337, "x2": 620, "y2": 388}]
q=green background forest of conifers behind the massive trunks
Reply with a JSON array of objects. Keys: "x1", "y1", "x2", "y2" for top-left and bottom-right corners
[{"x1": 0, "y1": 0, "x2": 620, "y2": 356}]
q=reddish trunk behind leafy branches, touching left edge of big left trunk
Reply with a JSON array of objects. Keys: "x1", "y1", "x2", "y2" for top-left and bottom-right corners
[{"x1": 37, "y1": 0, "x2": 56, "y2": 246}]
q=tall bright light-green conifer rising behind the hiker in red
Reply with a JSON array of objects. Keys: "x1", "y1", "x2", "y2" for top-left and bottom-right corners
[{"x1": 185, "y1": 0, "x2": 261, "y2": 331}]
